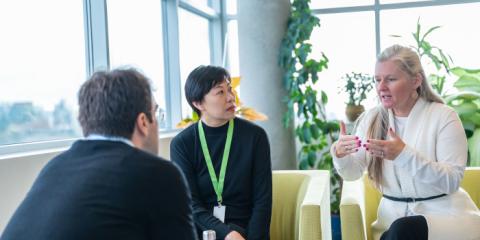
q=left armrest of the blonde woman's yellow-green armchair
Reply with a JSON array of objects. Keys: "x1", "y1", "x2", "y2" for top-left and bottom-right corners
[{"x1": 340, "y1": 178, "x2": 366, "y2": 240}]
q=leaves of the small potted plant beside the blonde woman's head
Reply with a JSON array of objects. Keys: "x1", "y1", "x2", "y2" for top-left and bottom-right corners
[{"x1": 342, "y1": 72, "x2": 373, "y2": 106}]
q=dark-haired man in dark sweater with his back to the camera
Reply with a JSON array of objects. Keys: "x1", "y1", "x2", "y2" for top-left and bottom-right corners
[{"x1": 1, "y1": 69, "x2": 196, "y2": 240}]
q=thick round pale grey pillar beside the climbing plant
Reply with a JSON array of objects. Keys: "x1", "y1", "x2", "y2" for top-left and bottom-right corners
[{"x1": 237, "y1": 0, "x2": 297, "y2": 169}]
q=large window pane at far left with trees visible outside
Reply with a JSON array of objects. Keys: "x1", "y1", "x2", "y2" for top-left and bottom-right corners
[{"x1": 0, "y1": 0, "x2": 86, "y2": 145}]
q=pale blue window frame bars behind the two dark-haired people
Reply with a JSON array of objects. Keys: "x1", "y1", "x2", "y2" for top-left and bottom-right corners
[{"x1": 0, "y1": 0, "x2": 226, "y2": 156}]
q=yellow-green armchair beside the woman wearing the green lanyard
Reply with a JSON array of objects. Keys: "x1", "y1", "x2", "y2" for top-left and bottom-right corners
[{"x1": 270, "y1": 170, "x2": 331, "y2": 240}]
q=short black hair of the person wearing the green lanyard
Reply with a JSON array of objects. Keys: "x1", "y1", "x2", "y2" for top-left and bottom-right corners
[{"x1": 185, "y1": 65, "x2": 231, "y2": 116}]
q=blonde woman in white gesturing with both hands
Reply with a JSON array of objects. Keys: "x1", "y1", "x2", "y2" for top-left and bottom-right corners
[{"x1": 331, "y1": 45, "x2": 480, "y2": 240}]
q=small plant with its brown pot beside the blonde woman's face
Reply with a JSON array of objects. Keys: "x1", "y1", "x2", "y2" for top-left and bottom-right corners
[{"x1": 342, "y1": 72, "x2": 373, "y2": 122}]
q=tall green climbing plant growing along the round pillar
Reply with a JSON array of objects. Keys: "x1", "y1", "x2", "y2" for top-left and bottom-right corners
[{"x1": 279, "y1": 0, "x2": 341, "y2": 214}]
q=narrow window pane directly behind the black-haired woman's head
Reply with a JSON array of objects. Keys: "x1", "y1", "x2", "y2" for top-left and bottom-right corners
[{"x1": 178, "y1": 8, "x2": 211, "y2": 118}]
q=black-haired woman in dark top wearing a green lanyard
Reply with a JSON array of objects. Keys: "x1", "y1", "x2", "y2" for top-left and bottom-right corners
[{"x1": 170, "y1": 66, "x2": 272, "y2": 240}]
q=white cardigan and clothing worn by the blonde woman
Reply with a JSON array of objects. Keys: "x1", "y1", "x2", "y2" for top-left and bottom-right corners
[{"x1": 331, "y1": 99, "x2": 480, "y2": 240}]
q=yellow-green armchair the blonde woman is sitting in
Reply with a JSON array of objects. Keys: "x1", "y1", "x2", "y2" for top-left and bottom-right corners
[{"x1": 340, "y1": 167, "x2": 480, "y2": 240}]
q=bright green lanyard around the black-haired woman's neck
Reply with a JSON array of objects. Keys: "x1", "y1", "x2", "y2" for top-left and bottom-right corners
[{"x1": 198, "y1": 119, "x2": 233, "y2": 205}]
